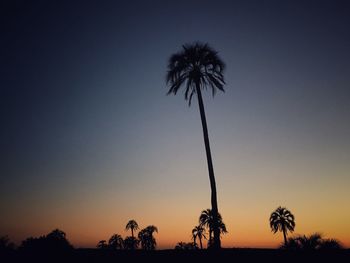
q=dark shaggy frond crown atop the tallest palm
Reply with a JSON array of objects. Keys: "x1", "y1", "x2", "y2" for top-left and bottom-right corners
[{"x1": 166, "y1": 43, "x2": 225, "y2": 105}]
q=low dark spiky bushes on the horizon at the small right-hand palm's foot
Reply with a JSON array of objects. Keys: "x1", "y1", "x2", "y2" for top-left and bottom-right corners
[{"x1": 281, "y1": 233, "x2": 342, "y2": 251}]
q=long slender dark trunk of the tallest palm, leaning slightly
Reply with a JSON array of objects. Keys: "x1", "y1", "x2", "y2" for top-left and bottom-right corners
[{"x1": 196, "y1": 84, "x2": 221, "y2": 249}]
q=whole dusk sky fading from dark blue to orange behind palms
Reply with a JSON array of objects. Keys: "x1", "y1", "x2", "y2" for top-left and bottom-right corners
[{"x1": 0, "y1": 0, "x2": 350, "y2": 248}]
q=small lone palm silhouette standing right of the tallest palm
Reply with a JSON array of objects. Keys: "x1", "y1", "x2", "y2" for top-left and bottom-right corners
[{"x1": 270, "y1": 206, "x2": 295, "y2": 246}]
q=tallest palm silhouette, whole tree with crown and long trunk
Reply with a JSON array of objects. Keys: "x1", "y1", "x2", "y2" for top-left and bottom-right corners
[{"x1": 166, "y1": 43, "x2": 225, "y2": 249}]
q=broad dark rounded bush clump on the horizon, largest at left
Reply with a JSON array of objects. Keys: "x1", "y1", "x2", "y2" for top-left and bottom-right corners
[{"x1": 20, "y1": 229, "x2": 73, "y2": 252}]
